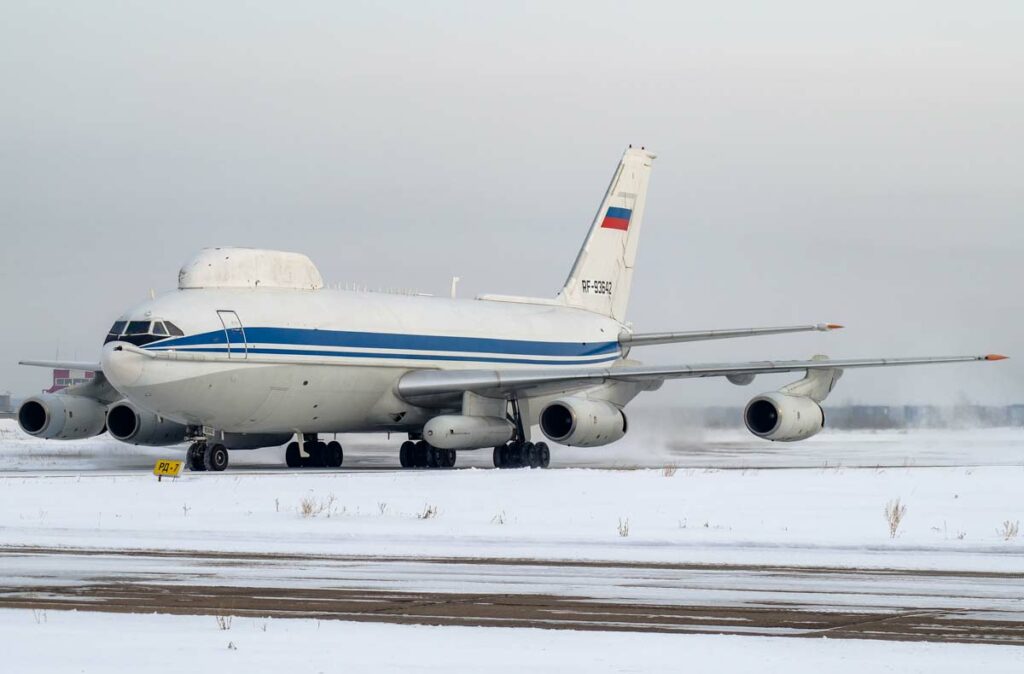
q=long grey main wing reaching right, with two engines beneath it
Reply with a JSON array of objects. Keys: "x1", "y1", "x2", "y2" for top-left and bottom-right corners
[{"x1": 397, "y1": 353, "x2": 1007, "y2": 404}]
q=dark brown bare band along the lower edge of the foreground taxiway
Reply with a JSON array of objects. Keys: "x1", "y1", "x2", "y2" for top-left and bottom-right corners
[{"x1": 0, "y1": 583, "x2": 1024, "y2": 645}]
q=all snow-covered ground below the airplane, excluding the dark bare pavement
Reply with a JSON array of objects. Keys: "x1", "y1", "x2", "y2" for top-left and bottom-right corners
[{"x1": 0, "y1": 425, "x2": 1024, "y2": 672}]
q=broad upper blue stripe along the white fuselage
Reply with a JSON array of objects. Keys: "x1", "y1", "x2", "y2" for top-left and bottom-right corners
[{"x1": 146, "y1": 328, "x2": 620, "y2": 360}]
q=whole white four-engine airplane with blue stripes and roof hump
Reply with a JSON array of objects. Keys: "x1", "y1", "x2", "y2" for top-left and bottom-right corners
[{"x1": 17, "y1": 145, "x2": 1006, "y2": 471}]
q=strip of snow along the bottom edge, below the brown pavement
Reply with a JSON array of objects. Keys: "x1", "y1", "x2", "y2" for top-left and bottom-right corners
[{"x1": 0, "y1": 610, "x2": 1024, "y2": 674}]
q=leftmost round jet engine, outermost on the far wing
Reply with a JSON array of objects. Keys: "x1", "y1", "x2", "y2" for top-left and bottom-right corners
[{"x1": 17, "y1": 393, "x2": 106, "y2": 440}]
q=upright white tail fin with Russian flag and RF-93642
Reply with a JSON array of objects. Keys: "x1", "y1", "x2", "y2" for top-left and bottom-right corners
[{"x1": 558, "y1": 146, "x2": 654, "y2": 321}]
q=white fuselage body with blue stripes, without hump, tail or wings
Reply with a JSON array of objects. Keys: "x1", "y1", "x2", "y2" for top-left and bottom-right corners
[{"x1": 102, "y1": 288, "x2": 626, "y2": 433}]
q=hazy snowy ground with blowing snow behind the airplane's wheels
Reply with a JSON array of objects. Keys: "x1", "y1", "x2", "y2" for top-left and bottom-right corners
[{"x1": 6, "y1": 412, "x2": 1024, "y2": 472}]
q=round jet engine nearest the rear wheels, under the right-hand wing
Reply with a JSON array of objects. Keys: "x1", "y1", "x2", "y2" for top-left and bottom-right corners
[{"x1": 541, "y1": 397, "x2": 628, "y2": 447}]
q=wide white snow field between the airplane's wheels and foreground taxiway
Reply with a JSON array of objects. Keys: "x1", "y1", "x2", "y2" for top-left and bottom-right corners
[{"x1": 0, "y1": 419, "x2": 1024, "y2": 571}]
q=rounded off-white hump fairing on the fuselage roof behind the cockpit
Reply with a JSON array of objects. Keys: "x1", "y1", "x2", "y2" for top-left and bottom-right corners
[{"x1": 178, "y1": 248, "x2": 324, "y2": 290}]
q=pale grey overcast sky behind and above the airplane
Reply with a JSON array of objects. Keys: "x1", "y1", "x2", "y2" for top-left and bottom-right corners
[{"x1": 0, "y1": 0, "x2": 1024, "y2": 405}]
